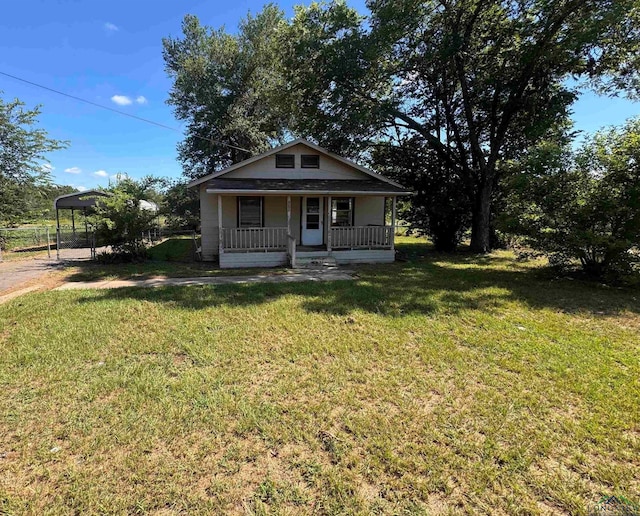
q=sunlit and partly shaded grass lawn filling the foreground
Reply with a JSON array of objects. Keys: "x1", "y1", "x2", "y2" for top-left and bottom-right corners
[{"x1": 0, "y1": 238, "x2": 640, "y2": 514}]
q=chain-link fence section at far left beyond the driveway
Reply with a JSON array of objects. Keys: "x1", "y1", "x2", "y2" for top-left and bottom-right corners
[{"x1": 0, "y1": 227, "x2": 55, "y2": 261}]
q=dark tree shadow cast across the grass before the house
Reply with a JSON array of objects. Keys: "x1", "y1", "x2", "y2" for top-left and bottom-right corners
[{"x1": 71, "y1": 242, "x2": 640, "y2": 317}]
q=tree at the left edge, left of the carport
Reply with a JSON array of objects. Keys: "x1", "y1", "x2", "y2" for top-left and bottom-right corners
[{"x1": 0, "y1": 94, "x2": 67, "y2": 224}]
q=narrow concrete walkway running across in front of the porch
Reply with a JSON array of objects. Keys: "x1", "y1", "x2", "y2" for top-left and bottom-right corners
[{"x1": 54, "y1": 269, "x2": 355, "y2": 290}]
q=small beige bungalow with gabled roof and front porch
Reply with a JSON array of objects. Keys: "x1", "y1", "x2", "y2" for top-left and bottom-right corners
[{"x1": 189, "y1": 139, "x2": 411, "y2": 268}]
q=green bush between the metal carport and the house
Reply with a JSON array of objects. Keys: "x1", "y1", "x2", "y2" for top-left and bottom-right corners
[{"x1": 93, "y1": 177, "x2": 160, "y2": 261}]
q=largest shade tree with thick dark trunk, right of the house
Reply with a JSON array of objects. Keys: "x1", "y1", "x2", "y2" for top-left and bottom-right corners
[{"x1": 281, "y1": 0, "x2": 640, "y2": 252}]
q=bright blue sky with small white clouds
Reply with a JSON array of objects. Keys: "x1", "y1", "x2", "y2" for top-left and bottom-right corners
[{"x1": 0, "y1": 0, "x2": 640, "y2": 188}]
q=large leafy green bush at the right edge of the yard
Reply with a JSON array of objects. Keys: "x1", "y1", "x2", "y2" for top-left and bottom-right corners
[{"x1": 505, "y1": 119, "x2": 640, "y2": 277}]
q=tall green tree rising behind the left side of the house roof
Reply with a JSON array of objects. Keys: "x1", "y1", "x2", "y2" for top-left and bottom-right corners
[{"x1": 163, "y1": 4, "x2": 285, "y2": 179}]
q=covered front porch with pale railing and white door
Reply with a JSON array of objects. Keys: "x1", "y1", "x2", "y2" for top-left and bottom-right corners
[{"x1": 216, "y1": 194, "x2": 396, "y2": 268}]
